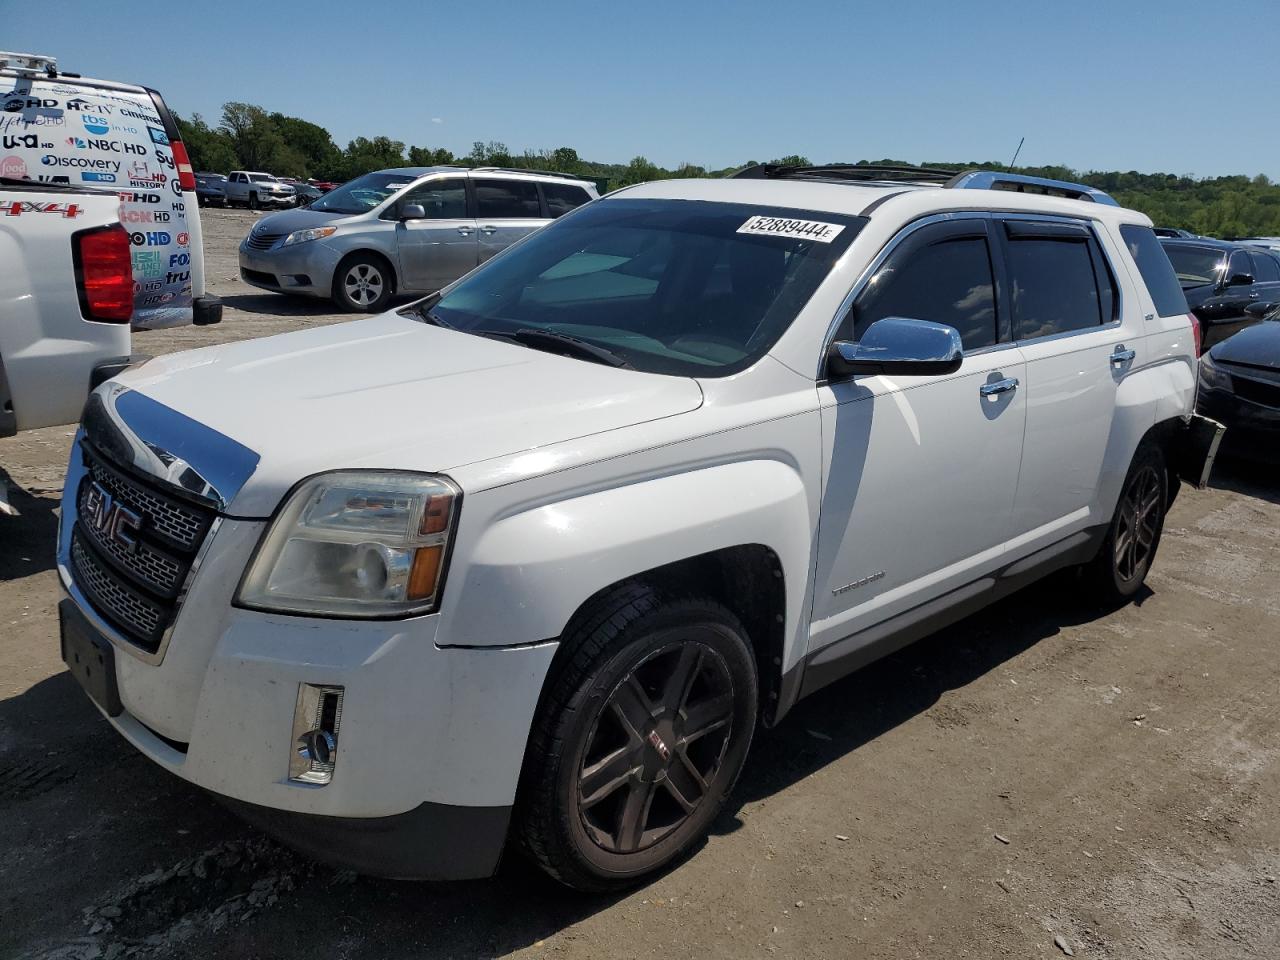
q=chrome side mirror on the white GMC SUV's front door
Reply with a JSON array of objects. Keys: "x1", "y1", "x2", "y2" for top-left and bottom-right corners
[{"x1": 827, "y1": 316, "x2": 964, "y2": 379}]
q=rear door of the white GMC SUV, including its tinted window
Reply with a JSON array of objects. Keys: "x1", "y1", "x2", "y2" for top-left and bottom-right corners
[{"x1": 996, "y1": 215, "x2": 1146, "y2": 553}]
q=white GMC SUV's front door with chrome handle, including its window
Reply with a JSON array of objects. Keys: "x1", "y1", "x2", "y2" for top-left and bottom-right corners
[{"x1": 810, "y1": 216, "x2": 1027, "y2": 650}]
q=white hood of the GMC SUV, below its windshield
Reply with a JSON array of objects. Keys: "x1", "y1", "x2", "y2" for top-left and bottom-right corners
[{"x1": 115, "y1": 314, "x2": 703, "y2": 517}]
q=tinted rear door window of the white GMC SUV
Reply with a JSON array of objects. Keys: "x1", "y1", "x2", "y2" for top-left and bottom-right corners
[{"x1": 1005, "y1": 220, "x2": 1116, "y2": 340}]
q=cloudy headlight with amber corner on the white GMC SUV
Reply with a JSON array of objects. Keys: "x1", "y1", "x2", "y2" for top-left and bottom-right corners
[{"x1": 236, "y1": 470, "x2": 462, "y2": 617}]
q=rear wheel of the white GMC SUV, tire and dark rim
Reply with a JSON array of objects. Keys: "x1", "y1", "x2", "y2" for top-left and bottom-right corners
[{"x1": 1085, "y1": 442, "x2": 1170, "y2": 605}]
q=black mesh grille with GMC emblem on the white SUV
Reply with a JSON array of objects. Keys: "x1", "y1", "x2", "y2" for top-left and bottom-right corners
[{"x1": 70, "y1": 443, "x2": 214, "y2": 653}]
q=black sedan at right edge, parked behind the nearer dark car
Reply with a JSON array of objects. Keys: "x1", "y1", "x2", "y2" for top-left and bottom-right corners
[{"x1": 1160, "y1": 237, "x2": 1280, "y2": 349}]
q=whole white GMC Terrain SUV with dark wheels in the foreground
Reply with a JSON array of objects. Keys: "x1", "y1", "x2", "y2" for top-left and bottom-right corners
[{"x1": 58, "y1": 166, "x2": 1215, "y2": 890}]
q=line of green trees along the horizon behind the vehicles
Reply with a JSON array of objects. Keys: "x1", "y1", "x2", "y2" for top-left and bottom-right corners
[{"x1": 178, "y1": 102, "x2": 1280, "y2": 237}]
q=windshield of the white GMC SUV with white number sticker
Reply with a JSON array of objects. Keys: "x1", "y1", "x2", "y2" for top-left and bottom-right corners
[{"x1": 421, "y1": 198, "x2": 867, "y2": 376}]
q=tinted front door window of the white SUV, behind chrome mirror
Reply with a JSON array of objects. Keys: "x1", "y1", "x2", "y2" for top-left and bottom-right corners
[{"x1": 841, "y1": 221, "x2": 996, "y2": 349}]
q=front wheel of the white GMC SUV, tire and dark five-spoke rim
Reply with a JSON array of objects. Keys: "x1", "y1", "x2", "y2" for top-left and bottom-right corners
[{"x1": 517, "y1": 586, "x2": 759, "y2": 891}]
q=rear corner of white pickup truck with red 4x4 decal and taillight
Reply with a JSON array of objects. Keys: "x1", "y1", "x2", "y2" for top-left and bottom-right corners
[{"x1": 0, "y1": 177, "x2": 133, "y2": 513}]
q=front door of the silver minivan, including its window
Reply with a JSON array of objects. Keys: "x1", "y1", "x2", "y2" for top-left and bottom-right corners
[{"x1": 390, "y1": 177, "x2": 477, "y2": 293}]
